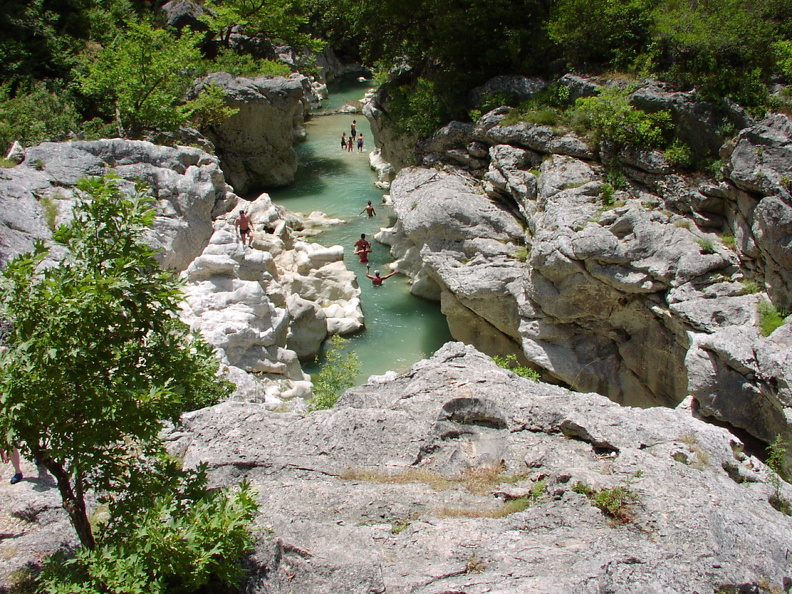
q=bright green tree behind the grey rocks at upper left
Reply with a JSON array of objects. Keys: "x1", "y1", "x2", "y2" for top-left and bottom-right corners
[{"x1": 77, "y1": 23, "x2": 201, "y2": 138}]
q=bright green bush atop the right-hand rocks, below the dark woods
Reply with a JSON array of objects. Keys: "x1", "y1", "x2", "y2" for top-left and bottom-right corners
[{"x1": 571, "y1": 87, "x2": 671, "y2": 148}]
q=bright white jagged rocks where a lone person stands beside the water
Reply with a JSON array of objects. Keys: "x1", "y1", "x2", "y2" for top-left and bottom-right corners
[{"x1": 182, "y1": 194, "x2": 363, "y2": 398}]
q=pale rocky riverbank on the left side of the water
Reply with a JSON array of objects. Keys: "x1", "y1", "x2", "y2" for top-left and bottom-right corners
[{"x1": 0, "y1": 133, "x2": 363, "y2": 408}]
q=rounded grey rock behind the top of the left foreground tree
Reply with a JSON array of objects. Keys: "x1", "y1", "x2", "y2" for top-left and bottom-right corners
[{"x1": 0, "y1": 139, "x2": 229, "y2": 271}]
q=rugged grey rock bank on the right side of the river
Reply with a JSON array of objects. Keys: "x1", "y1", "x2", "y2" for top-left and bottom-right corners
[{"x1": 367, "y1": 76, "x2": 792, "y2": 454}]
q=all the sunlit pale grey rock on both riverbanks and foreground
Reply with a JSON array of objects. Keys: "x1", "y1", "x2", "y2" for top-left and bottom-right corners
[{"x1": 0, "y1": 69, "x2": 792, "y2": 594}]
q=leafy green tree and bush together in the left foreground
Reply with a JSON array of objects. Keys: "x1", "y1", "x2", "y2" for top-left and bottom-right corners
[{"x1": 0, "y1": 178, "x2": 257, "y2": 594}]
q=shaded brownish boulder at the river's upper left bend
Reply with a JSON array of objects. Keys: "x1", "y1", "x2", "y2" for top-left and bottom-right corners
[{"x1": 194, "y1": 72, "x2": 310, "y2": 195}]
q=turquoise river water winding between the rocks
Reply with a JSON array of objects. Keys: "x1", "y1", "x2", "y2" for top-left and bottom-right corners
[{"x1": 269, "y1": 80, "x2": 451, "y2": 384}]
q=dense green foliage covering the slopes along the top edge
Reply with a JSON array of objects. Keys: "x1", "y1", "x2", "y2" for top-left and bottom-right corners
[{"x1": 0, "y1": 0, "x2": 792, "y2": 150}]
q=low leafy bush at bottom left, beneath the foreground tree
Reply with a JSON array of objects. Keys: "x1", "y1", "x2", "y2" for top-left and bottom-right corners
[{"x1": 41, "y1": 463, "x2": 258, "y2": 594}]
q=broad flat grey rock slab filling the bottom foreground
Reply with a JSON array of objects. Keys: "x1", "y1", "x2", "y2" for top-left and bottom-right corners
[{"x1": 166, "y1": 343, "x2": 792, "y2": 594}]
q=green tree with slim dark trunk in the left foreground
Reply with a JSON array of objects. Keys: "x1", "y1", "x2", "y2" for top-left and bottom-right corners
[{"x1": 0, "y1": 178, "x2": 229, "y2": 549}]
